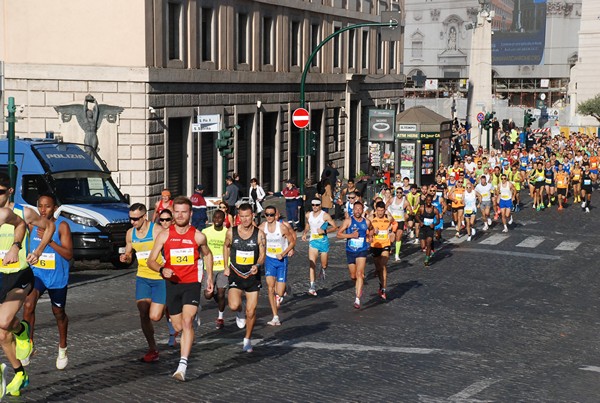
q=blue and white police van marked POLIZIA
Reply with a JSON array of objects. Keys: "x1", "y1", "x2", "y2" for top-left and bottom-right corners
[{"x1": 0, "y1": 139, "x2": 131, "y2": 268}]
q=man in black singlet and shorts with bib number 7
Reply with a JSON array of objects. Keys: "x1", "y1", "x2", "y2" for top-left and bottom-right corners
[{"x1": 223, "y1": 203, "x2": 266, "y2": 353}]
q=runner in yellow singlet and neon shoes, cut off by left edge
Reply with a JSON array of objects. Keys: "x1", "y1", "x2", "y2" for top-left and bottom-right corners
[{"x1": 0, "y1": 173, "x2": 56, "y2": 396}]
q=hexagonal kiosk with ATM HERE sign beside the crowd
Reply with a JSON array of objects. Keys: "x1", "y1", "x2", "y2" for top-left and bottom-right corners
[{"x1": 395, "y1": 106, "x2": 452, "y2": 185}]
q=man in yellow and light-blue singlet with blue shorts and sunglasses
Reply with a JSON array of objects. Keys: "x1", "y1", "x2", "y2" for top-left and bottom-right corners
[{"x1": 119, "y1": 203, "x2": 167, "y2": 362}]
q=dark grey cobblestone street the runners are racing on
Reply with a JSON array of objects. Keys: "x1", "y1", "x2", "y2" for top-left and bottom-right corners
[{"x1": 12, "y1": 196, "x2": 600, "y2": 402}]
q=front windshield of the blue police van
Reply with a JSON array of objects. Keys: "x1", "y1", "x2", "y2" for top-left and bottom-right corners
[{"x1": 52, "y1": 172, "x2": 126, "y2": 204}]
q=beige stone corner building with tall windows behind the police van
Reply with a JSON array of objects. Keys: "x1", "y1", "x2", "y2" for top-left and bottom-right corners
[{"x1": 0, "y1": 0, "x2": 405, "y2": 205}]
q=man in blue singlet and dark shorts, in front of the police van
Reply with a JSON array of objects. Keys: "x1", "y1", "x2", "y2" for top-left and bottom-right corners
[{"x1": 22, "y1": 194, "x2": 73, "y2": 369}]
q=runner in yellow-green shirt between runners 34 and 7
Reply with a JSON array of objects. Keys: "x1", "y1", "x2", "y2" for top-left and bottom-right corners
[{"x1": 202, "y1": 210, "x2": 229, "y2": 330}]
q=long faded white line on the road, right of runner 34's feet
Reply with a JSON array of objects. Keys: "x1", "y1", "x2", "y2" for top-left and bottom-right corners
[{"x1": 200, "y1": 338, "x2": 478, "y2": 357}]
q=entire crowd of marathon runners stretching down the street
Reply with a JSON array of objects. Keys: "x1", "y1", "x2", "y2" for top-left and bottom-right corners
[{"x1": 0, "y1": 133, "x2": 600, "y2": 396}]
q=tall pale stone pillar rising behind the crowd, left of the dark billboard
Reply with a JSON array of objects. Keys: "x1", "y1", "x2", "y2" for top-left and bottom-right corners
[{"x1": 467, "y1": 0, "x2": 493, "y2": 148}]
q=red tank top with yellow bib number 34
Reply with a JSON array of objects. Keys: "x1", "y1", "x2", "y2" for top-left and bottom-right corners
[{"x1": 163, "y1": 226, "x2": 203, "y2": 283}]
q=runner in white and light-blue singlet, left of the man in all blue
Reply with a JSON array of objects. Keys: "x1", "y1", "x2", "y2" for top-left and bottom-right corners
[{"x1": 302, "y1": 200, "x2": 336, "y2": 297}]
